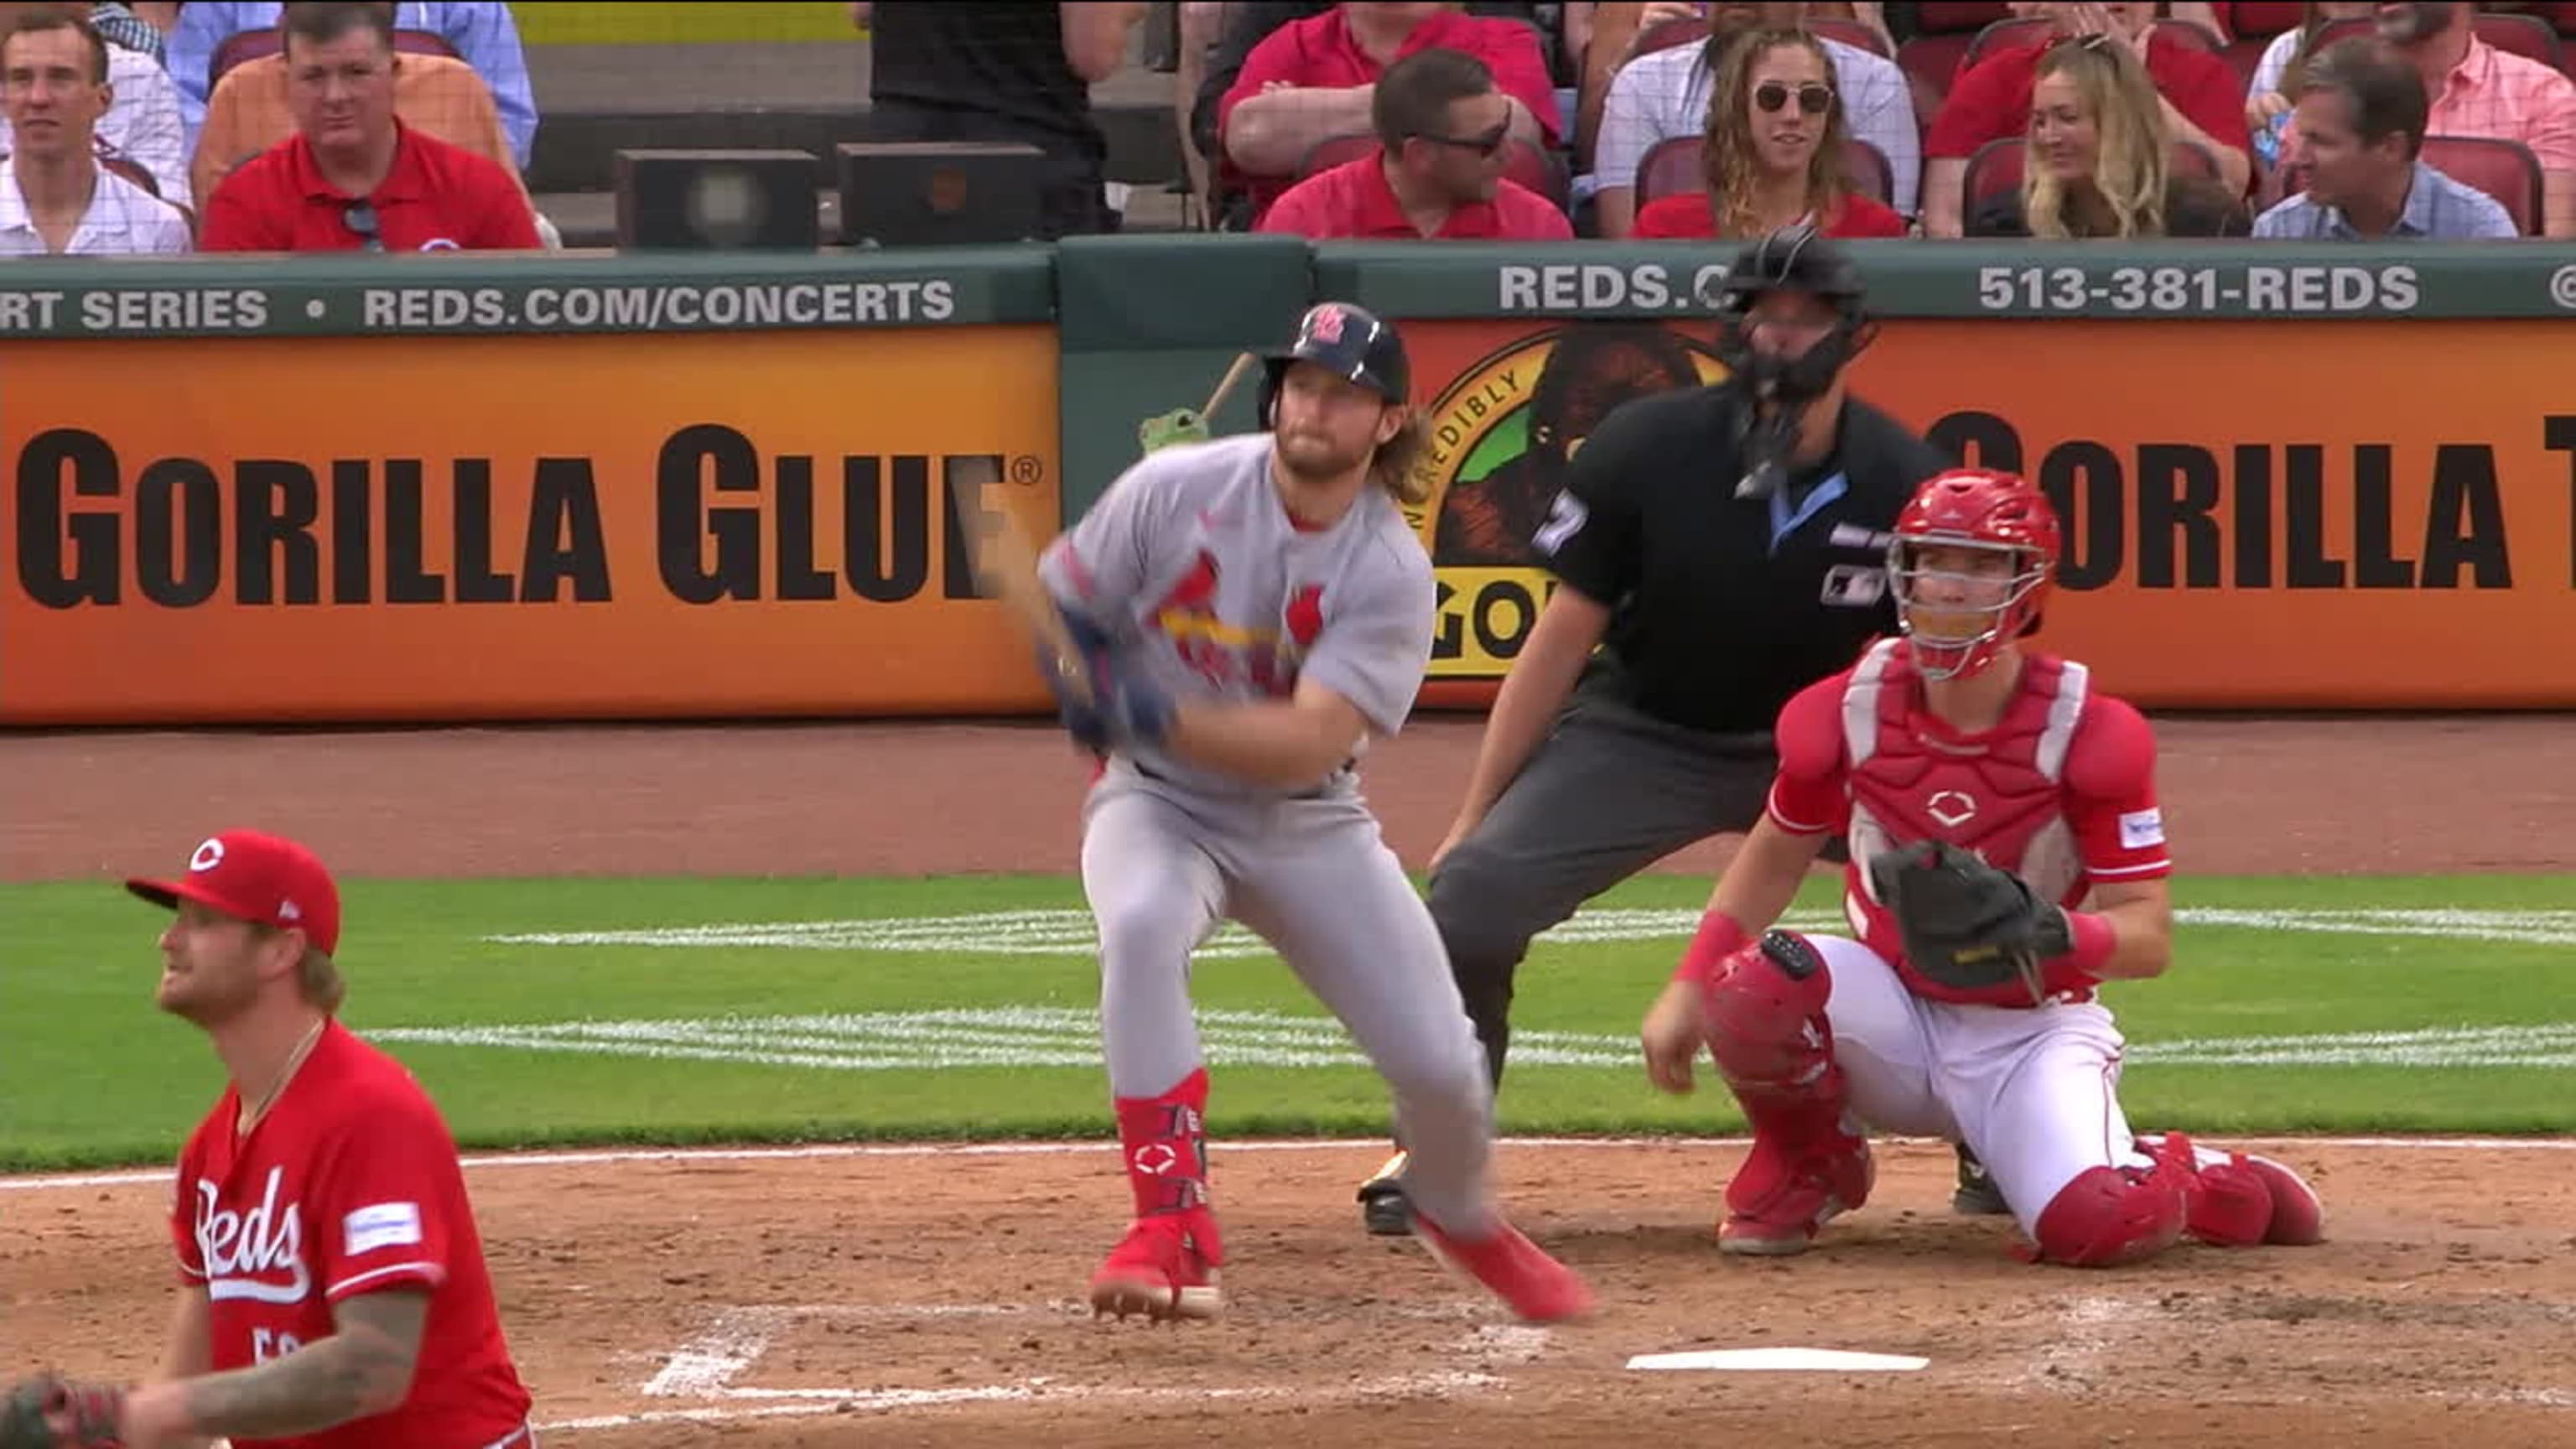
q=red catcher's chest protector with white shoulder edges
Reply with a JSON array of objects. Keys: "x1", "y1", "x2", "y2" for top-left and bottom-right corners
[{"x1": 1841, "y1": 640, "x2": 2086, "y2": 907}]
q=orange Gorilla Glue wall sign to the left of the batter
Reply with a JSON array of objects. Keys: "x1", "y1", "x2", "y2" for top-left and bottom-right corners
[{"x1": 0, "y1": 327, "x2": 1062, "y2": 724}]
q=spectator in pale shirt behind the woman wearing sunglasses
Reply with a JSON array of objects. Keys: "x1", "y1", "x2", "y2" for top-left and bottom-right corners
[{"x1": 1592, "y1": 3, "x2": 1922, "y2": 237}]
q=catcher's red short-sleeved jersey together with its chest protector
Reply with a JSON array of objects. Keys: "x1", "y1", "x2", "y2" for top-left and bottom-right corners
[{"x1": 1769, "y1": 640, "x2": 2174, "y2": 1005}]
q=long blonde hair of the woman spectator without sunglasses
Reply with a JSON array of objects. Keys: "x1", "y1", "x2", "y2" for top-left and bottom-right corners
[{"x1": 2023, "y1": 36, "x2": 2174, "y2": 240}]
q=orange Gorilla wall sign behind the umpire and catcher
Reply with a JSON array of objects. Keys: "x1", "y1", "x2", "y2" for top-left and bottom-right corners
[{"x1": 1404, "y1": 317, "x2": 2576, "y2": 709}]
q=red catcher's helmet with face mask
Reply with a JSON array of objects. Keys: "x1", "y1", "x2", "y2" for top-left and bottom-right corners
[{"x1": 1888, "y1": 467, "x2": 2059, "y2": 678}]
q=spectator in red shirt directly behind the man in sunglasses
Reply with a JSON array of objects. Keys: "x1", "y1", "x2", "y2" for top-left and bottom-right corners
[{"x1": 1216, "y1": 3, "x2": 1559, "y2": 225}]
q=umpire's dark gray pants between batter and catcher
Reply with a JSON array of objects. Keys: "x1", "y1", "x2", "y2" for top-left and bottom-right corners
[{"x1": 1432, "y1": 676, "x2": 1778, "y2": 1085}]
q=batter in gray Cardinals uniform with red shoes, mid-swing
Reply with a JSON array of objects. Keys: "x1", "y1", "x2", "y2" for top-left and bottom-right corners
[{"x1": 1041, "y1": 302, "x2": 1587, "y2": 1320}]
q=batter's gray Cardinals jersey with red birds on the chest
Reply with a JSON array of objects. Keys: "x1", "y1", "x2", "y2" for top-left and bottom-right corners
[{"x1": 1041, "y1": 434, "x2": 1435, "y2": 794}]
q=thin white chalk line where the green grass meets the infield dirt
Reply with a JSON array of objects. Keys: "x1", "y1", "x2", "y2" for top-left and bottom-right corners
[{"x1": 0, "y1": 1135, "x2": 2576, "y2": 1192}]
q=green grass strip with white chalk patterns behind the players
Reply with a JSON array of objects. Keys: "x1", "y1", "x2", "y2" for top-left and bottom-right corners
[{"x1": 0, "y1": 860, "x2": 2576, "y2": 1171}]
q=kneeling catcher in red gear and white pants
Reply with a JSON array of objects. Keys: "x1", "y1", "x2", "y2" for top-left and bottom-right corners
[{"x1": 1644, "y1": 470, "x2": 2324, "y2": 1266}]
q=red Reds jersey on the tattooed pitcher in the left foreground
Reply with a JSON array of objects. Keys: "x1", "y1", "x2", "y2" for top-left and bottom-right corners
[{"x1": 170, "y1": 1021, "x2": 528, "y2": 1449}]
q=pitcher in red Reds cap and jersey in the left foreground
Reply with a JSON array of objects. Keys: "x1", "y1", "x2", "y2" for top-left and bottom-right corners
[{"x1": 0, "y1": 830, "x2": 536, "y2": 1449}]
